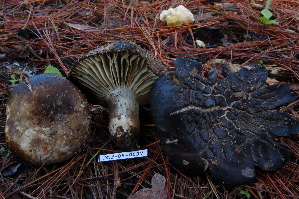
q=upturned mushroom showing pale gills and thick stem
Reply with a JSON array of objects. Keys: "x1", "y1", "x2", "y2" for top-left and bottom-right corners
[{"x1": 69, "y1": 41, "x2": 165, "y2": 150}]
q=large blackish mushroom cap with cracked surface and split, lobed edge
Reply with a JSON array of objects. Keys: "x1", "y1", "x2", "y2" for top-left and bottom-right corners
[{"x1": 150, "y1": 58, "x2": 299, "y2": 185}]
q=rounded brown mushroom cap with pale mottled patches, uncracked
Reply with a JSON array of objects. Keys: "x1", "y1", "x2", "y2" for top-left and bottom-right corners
[{"x1": 5, "y1": 73, "x2": 90, "y2": 165}]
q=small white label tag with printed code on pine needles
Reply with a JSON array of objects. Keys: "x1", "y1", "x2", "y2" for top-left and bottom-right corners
[{"x1": 98, "y1": 149, "x2": 147, "y2": 162}]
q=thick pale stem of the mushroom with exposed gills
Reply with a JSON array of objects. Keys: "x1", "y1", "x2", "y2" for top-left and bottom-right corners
[{"x1": 107, "y1": 88, "x2": 140, "y2": 150}]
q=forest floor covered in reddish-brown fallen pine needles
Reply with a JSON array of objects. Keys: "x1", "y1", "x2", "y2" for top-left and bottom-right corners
[{"x1": 0, "y1": 0, "x2": 299, "y2": 199}]
